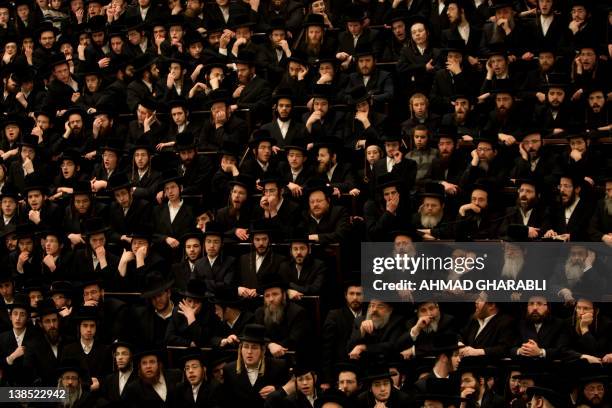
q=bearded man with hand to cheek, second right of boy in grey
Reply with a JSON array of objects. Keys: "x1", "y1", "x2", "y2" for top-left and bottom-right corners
[{"x1": 459, "y1": 134, "x2": 508, "y2": 190}]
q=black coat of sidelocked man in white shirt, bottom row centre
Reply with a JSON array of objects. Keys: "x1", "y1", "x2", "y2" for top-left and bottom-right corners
[{"x1": 221, "y1": 357, "x2": 289, "y2": 408}]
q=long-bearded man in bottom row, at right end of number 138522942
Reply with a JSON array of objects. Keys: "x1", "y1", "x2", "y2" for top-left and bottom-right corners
[{"x1": 56, "y1": 359, "x2": 96, "y2": 408}]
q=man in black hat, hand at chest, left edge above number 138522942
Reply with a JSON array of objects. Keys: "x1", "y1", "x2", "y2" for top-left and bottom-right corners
[{"x1": 0, "y1": 295, "x2": 40, "y2": 386}]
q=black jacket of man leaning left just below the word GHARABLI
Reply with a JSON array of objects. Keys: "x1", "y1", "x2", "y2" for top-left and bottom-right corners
[{"x1": 462, "y1": 313, "x2": 516, "y2": 358}]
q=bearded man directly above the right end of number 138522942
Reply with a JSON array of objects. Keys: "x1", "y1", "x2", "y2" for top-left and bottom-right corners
[{"x1": 36, "y1": 300, "x2": 66, "y2": 387}]
